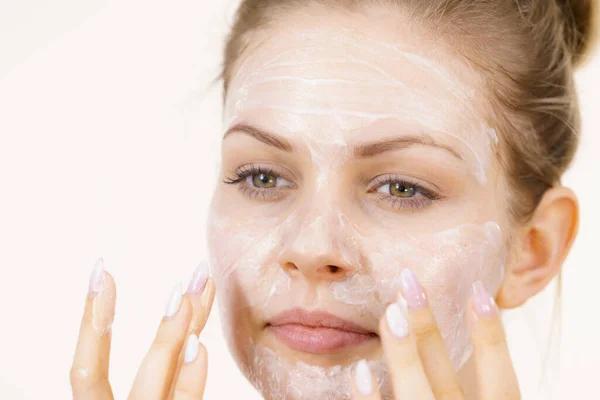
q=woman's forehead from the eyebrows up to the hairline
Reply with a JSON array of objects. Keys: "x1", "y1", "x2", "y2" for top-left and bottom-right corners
[{"x1": 225, "y1": 16, "x2": 495, "y2": 181}]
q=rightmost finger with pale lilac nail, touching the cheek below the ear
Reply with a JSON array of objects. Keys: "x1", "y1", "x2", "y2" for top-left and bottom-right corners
[{"x1": 469, "y1": 282, "x2": 521, "y2": 400}]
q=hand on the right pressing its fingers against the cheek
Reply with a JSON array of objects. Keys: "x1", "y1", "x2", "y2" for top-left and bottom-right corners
[{"x1": 352, "y1": 270, "x2": 521, "y2": 400}]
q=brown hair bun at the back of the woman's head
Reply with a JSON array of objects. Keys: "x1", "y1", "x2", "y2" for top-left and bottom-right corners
[{"x1": 558, "y1": 0, "x2": 600, "y2": 67}]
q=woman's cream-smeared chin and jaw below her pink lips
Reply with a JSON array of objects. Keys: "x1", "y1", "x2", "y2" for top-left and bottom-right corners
[{"x1": 228, "y1": 325, "x2": 391, "y2": 400}]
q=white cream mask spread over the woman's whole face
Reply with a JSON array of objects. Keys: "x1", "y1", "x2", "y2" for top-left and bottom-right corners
[{"x1": 209, "y1": 20, "x2": 506, "y2": 399}]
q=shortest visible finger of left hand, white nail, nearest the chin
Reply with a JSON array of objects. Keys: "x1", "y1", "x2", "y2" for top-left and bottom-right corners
[{"x1": 173, "y1": 334, "x2": 208, "y2": 400}]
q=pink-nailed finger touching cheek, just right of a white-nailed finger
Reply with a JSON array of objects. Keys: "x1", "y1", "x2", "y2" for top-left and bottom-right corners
[{"x1": 400, "y1": 268, "x2": 464, "y2": 400}]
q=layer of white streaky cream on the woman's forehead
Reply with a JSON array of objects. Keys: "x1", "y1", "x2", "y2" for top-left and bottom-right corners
[{"x1": 225, "y1": 30, "x2": 497, "y2": 183}]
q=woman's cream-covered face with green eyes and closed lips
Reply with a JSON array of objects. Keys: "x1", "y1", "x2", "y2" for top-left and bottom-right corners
[{"x1": 209, "y1": 7, "x2": 508, "y2": 398}]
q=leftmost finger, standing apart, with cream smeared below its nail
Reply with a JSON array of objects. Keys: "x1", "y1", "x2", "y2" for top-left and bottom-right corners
[{"x1": 70, "y1": 258, "x2": 116, "y2": 400}]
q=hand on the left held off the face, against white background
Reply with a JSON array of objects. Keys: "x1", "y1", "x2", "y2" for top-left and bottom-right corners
[{"x1": 71, "y1": 259, "x2": 215, "y2": 400}]
